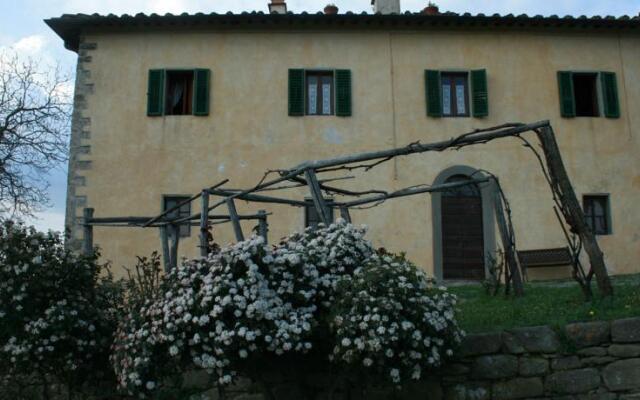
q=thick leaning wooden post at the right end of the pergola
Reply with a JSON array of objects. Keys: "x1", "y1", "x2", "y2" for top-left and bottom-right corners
[{"x1": 537, "y1": 126, "x2": 613, "y2": 297}]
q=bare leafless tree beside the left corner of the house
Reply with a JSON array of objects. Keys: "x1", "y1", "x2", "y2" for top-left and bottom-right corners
[{"x1": 0, "y1": 50, "x2": 71, "y2": 215}]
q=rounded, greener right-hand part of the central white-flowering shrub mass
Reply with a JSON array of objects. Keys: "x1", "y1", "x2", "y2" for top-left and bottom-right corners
[{"x1": 330, "y1": 254, "x2": 464, "y2": 384}]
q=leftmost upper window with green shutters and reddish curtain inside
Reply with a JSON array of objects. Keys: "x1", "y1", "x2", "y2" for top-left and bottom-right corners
[{"x1": 147, "y1": 69, "x2": 210, "y2": 116}]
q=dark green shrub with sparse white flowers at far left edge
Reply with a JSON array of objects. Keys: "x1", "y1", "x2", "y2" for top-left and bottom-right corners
[{"x1": 0, "y1": 221, "x2": 122, "y2": 390}]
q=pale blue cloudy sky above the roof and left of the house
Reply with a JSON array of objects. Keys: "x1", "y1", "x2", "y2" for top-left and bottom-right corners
[{"x1": 0, "y1": 0, "x2": 640, "y2": 230}]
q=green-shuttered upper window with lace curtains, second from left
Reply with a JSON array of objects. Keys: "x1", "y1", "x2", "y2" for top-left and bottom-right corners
[{"x1": 289, "y1": 69, "x2": 351, "y2": 117}]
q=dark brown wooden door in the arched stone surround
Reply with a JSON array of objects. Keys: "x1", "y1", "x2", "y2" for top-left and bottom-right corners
[{"x1": 442, "y1": 175, "x2": 485, "y2": 280}]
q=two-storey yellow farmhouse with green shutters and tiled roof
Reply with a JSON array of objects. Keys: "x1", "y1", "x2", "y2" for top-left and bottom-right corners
[{"x1": 46, "y1": 0, "x2": 640, "y2": 280}]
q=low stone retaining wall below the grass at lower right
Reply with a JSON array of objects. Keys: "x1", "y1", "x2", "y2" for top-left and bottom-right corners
[{"x1": 221, "y1": 318, "x2": 640, "y2": 400}]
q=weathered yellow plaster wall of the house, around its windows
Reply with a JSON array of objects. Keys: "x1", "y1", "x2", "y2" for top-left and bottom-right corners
[{"x1": 72, "y1": 31, "x2": 640, "y2": 277}]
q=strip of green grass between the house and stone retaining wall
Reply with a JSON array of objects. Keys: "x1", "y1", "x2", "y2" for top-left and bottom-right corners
[{"x1": 449, "y1": 274, "x2": 640, "y2": 333}]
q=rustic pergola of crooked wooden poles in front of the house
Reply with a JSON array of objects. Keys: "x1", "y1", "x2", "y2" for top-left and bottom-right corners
[{"x1": 84, "y1": 121, "x2": 613, "y2": 296}]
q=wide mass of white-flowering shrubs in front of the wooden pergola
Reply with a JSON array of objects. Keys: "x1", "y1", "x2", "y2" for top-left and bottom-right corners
[{"x1": 112, "y1": 220, "x2": 461, "y2": 398}]
